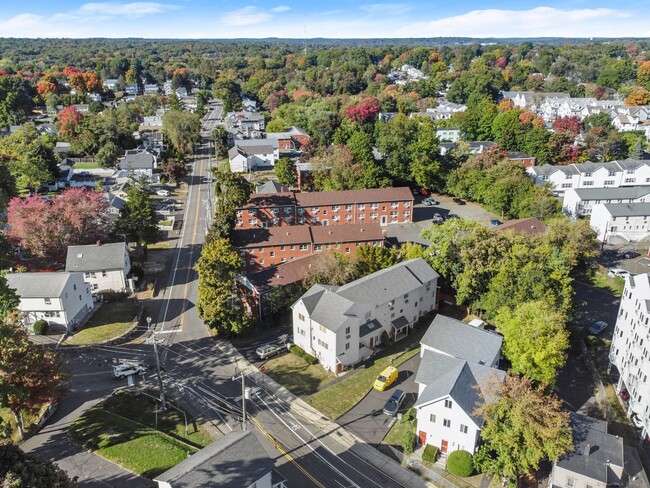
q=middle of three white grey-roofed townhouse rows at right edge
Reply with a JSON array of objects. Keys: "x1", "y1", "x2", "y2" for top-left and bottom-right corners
[{"x1": 562, "y1": 186, "x2": 650, "y2": 218}]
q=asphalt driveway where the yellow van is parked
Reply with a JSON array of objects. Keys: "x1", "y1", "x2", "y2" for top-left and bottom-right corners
[{"x1": 336, "y1": 355, "x2": 420, "y2": 445}]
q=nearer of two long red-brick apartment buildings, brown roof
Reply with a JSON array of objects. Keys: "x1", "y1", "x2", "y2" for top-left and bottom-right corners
[{"x1": 232, "y1": 223, "x2": 384, "y2": 273}]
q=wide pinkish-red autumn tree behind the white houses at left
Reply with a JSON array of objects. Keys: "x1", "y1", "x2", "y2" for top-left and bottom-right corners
[{"x1": 7, "y1": 188, "x2": 112, "y2": 265}]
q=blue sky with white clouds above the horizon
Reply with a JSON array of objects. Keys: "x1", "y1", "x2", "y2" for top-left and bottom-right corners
[{"x1": 0, "y1": 0, "x2": 650, "y2": 38}]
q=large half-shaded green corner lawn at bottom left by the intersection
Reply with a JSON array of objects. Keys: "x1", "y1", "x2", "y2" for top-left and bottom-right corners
[{"x1": 69, "y1": 392, "x2": 211, "y2": 478}]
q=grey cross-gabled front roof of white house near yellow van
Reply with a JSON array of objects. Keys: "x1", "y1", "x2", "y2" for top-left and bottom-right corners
[{"x1": 414, "y1": 350, "x2": 505, "y2": 427}]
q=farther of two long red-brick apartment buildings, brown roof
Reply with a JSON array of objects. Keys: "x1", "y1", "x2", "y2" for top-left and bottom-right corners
[{"x1": 235, "y1": 187, "x2": 414, "y2": 230}]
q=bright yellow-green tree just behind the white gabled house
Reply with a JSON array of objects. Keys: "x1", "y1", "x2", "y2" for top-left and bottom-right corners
[{"x1": 494, "y1": 300, "x2": 569, "y2": 387}]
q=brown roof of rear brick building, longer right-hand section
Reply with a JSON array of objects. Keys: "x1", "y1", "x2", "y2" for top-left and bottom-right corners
[{"x1": 296, "y1": 186, "x2": 413, "y2": 207}]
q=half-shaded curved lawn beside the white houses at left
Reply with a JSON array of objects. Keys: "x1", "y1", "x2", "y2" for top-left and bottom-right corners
[{"x1": 63, "y1": 300, "x2": 138, "y2": 346}]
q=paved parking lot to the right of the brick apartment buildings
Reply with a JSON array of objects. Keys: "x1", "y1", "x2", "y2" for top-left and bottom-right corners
[{"x1": 385, "y1": 193, "x2": 501, "y2": 246}]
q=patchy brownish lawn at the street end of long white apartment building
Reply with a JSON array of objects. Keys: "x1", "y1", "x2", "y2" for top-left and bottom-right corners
[{"x1": 264, "y1": 353, "x2": 336, "y2": 396}]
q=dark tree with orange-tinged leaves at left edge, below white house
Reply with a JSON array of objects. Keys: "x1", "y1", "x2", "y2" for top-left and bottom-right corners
[{"x1": 0, "y1": 317, "x2": 65, "y2": 439}]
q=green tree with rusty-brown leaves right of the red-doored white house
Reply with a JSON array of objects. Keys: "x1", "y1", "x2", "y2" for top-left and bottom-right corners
[{"x1": 474, "y1": 374, "x2": 573, "y2": 485}]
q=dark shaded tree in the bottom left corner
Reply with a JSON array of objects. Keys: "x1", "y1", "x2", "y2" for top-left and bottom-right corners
[{"x1": 0, "y1": 444, "x2": 77, "y2": 488}]
